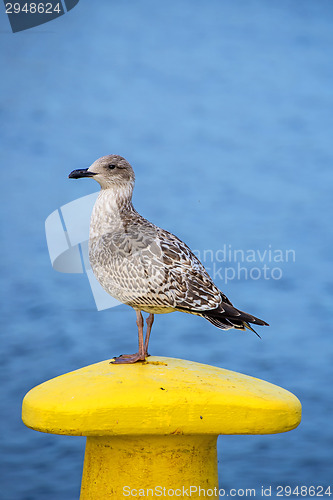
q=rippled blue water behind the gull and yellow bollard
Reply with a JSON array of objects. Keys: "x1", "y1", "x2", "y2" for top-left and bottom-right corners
[{"x1": 0, "y1": 0, "x2": 333, "y2": 500}]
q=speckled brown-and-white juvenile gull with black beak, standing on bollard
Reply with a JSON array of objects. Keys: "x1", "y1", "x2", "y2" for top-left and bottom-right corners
[{"x1": 69, "y1": 155, "x2": 267, "y2": 363}]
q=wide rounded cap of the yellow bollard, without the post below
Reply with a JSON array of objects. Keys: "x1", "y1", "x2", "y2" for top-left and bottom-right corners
[{"x1": 22, "y1": 356, "x2": 301, "y2": 436}]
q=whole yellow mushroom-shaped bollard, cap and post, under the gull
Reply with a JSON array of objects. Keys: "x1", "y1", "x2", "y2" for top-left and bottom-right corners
[{"x1": 22, "y1": 357, "x2": 301, "y2": 500}]
